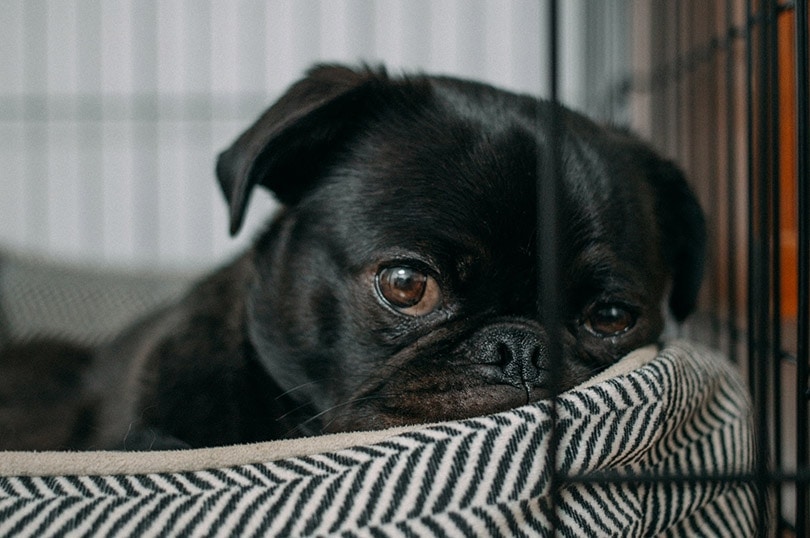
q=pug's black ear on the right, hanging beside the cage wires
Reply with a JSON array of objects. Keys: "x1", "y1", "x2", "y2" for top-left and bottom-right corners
[{"x1": 646, "y1": 152, "x2": 706, "y2": 321}]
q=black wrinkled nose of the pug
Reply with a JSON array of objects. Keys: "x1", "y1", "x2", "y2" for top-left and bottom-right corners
[{"x1": 470, "y1": 322, "x2": 548, "y2": 388}]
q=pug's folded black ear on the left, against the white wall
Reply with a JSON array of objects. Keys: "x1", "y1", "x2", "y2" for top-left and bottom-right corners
[{"x1": 217, "y1": 65, "x2": 387, "y2": 235}]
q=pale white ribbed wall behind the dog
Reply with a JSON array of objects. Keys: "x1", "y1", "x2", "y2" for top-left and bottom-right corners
[{"x1": 0, "y1": 0, "x2": 621, "y2": 267}]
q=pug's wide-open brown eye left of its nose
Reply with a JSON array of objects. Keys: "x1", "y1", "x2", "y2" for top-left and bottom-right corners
[{"x1": 377, "y1": 266, "x2": 441, "y2": 316}]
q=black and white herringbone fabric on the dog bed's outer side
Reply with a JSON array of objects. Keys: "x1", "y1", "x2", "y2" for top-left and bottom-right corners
[{"x1": 0, "y1": 342, "x2": 757, "y2": 536}]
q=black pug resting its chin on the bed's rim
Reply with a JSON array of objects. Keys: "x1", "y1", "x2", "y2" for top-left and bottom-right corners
[{"x1": 0, "y1": 66, "x2": 705, "y2": 449}]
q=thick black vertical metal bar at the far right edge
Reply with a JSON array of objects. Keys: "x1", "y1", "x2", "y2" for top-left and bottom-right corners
[{"x1": 795, "y1": 0, "x2": 810, "y2": 536}]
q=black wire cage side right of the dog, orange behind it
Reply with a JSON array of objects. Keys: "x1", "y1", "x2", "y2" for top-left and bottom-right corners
[{"x1": 616, "y1": 0, "x2": 810, "y2": 536}]
